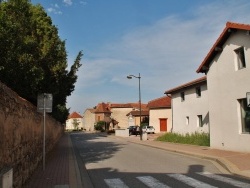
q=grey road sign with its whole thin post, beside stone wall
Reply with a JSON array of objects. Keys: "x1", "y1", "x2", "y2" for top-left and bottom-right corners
[{"x1": 37, "y1": 93, "x2": 53, "y2": 170}]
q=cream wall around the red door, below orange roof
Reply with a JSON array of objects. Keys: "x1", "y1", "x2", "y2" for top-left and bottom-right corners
[{"x1": 149, "y1": 108, "x2": 172, "y2": 133}]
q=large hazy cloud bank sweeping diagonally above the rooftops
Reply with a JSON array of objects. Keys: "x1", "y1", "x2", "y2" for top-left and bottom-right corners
[{"x1": 68, "y1": 1, "x2": 250, "y2": 111}]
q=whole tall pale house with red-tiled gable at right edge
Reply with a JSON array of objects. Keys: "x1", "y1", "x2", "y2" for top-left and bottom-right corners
[{"x1": 197, "y1": 22, "x2": 250, "y2": 152}]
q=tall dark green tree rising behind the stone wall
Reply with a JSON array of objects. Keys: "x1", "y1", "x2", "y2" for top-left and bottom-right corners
[{"x1": 0, "y1": 0, "x2": 83, "y2": 122}]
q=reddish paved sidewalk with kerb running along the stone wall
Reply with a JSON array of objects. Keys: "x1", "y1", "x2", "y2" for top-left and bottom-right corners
[{"x1": 25, "y1": 133, "x2": 82, "y2": 188}]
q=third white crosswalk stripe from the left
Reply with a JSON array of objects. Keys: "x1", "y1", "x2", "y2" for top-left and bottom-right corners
[{"x1": 167, "y1": 174, "x2": 218, "y2": 188}]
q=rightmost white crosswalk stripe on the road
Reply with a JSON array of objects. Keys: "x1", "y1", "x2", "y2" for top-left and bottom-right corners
[{"x1": 197, "y1": 172, "x2": 250, "y2": 188}]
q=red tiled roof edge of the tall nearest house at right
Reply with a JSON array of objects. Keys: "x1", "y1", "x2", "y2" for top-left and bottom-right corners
[{"x1": 196, "y1": 22, "x2": 250, "y2": 73}]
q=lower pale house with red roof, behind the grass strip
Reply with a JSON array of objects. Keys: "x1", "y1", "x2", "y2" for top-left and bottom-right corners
[{"x1": 165, "y1": 76, "x2": 209, "y2": 134}]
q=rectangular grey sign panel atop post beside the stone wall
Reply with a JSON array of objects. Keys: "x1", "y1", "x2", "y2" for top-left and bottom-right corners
[{"x1": 37, "y1": 93, "x2": 53, "y2": 112}]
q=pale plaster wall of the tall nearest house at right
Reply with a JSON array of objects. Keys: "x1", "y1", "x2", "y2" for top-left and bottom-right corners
[{"x1": 207, "y1": 31, "x2": 250, "y2": 152}]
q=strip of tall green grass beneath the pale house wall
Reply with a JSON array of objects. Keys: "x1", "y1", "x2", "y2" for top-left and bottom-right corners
[{"x1": 156, "y1": 132, "x2": 210, "y2": 146}]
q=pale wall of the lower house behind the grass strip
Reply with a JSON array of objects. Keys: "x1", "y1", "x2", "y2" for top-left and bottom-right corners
[{"x1": 171, "y1": 82, "x2": 209, "y2": 134}]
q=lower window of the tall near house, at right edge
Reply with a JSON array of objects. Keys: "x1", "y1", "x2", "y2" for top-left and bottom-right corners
[{"x1": 239, "y1": 98, "x2": 250, "y2": 133}]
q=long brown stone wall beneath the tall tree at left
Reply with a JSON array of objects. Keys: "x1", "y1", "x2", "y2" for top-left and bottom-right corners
[{"x1": 0, "y1": 82, "x2": 63, "y2": 187}]
